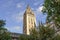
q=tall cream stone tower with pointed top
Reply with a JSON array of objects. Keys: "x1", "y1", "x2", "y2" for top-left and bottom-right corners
[{"x1": 23, "y1": 6, "x2": 36, "y2": 35}]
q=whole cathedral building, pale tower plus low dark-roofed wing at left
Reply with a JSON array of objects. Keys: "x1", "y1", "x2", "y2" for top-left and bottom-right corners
[{"x1": 10, "y1": 6, "x2": 36, "y2": 40}]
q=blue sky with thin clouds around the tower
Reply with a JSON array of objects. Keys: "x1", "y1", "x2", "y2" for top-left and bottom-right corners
[{"x1": 0, "y1": 0, "x2": 46, "y2": 33}]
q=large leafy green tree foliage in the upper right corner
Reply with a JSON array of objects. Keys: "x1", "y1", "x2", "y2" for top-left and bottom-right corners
[{"x1": 43, "y1": 0, "x2": 60, "y2": 28}]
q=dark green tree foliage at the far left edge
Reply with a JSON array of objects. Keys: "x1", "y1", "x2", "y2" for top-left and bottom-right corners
[{"x1": 0, "y1": 20, "x2": 11, "y2": 40}]
